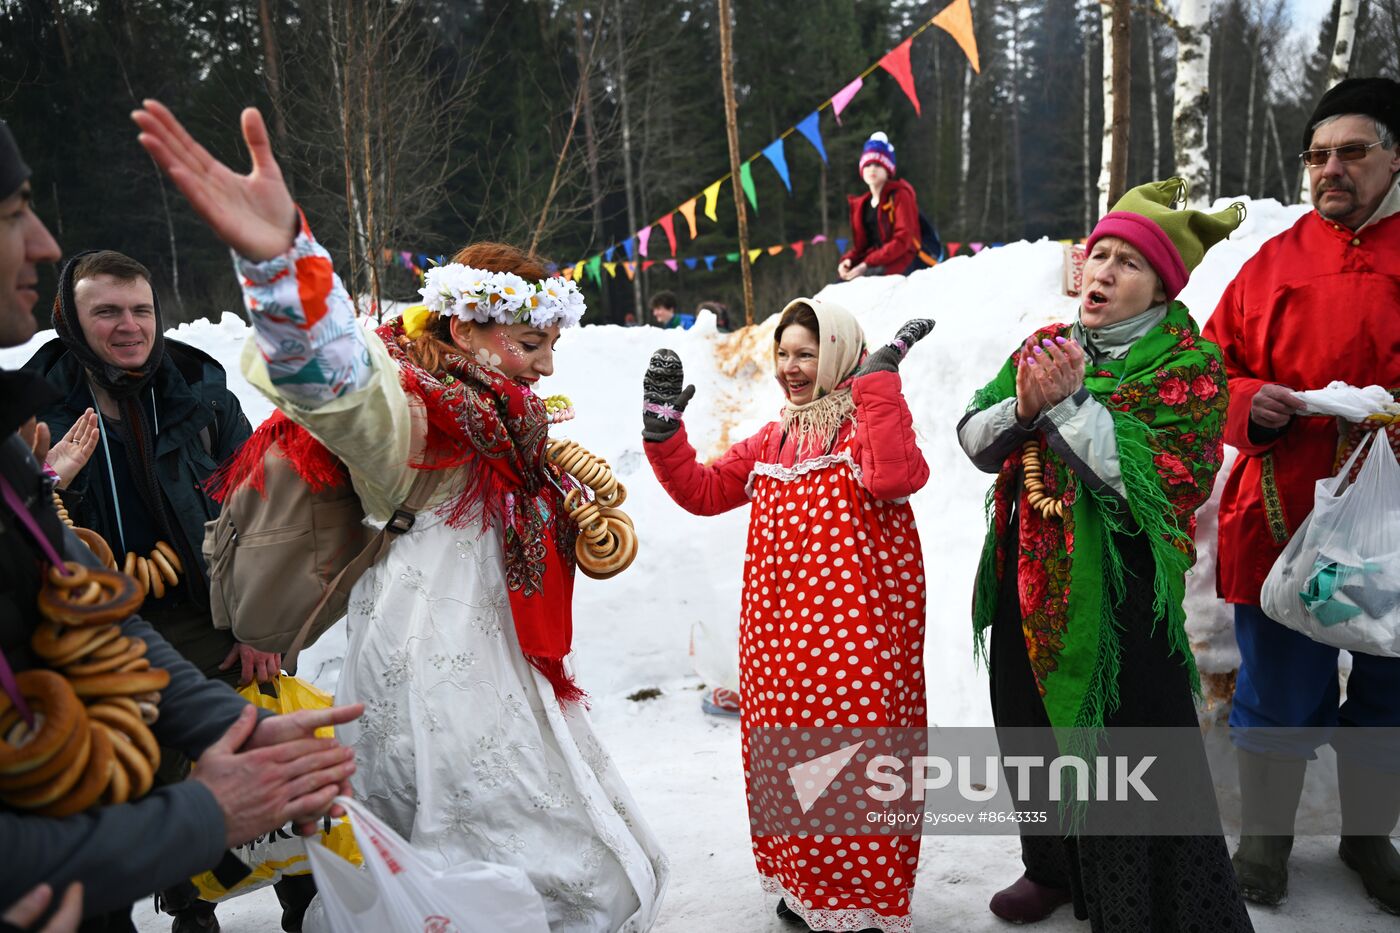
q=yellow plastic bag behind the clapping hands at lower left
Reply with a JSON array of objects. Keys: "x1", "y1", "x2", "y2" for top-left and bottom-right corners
[{"x1": 190, "y1": 674, "x2": 364, "y2": 901}]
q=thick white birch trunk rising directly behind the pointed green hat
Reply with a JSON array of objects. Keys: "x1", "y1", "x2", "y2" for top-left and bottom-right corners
[{"x1": 1172, "y1": 0, "x2": 1211, "y2": 207}]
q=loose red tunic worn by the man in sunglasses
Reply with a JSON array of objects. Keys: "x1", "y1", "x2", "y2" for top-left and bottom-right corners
[{"x1": 1204, "y1": 212, "x2": 1400, "y2": 605}]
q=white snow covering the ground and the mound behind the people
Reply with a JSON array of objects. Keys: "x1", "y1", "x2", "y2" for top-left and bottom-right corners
[{"x1": 0, "y1": 194, "x2": 1396, "y2": 933}]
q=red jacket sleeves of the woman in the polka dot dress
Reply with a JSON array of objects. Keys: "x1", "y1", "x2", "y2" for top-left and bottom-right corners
[{"x1": 643, "y1": 373, "x2": 928, "y2": 516}]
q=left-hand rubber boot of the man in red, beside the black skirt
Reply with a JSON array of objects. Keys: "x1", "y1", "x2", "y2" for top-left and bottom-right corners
[{"x1": 1231, "y1": 748, "x2": 1308, "y2": 906}]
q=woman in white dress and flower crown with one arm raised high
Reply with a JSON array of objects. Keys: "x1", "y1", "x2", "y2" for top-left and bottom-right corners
[{"x1": 134, "y1": 101, "x2": 668, "y2": 933}]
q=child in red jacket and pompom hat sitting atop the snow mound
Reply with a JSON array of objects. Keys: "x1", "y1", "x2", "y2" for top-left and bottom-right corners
[{"x1": 836, "y1": 133, "x2": 942, "y2": 282}]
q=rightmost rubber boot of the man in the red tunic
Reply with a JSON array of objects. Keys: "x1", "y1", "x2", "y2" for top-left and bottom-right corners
[{"x1": 1337, "y1": 755, "x2": 1400, "y2": 913}]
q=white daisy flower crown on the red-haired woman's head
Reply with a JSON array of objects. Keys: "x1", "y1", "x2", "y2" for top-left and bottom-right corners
[{"x1": 419, "y1": 262, "x2": 588, "y2": 328}]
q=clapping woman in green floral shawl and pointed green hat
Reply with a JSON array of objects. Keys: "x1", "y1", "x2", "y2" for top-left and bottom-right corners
[{"x1": 958, "y1": 178, "x2": 1253, "y2": 933}]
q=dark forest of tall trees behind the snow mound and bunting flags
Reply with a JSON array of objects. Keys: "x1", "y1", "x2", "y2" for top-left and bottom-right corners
[{"x1": 0, "y1": 0, "x2": 1400, "y2": 326}]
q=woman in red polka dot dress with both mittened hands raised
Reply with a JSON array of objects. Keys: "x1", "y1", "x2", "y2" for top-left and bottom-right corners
[{"x1": 643, "y1": 298, "x2": 934, "y2": 932}]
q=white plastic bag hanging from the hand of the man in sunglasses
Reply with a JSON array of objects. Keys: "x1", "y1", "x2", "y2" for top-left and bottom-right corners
[{"x1": 1260, "y1": 430, "x2": 1400, "y2": 657}]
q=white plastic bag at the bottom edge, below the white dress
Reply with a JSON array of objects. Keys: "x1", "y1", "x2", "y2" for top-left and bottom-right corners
[{"x1": 305, "y1": 797, "x2": 549, "y2": 933}]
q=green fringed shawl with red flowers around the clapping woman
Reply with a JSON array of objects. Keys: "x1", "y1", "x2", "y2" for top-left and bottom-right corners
[{"x1": 972, "y1": 301, "x2": 1228, "y2": 730}]
